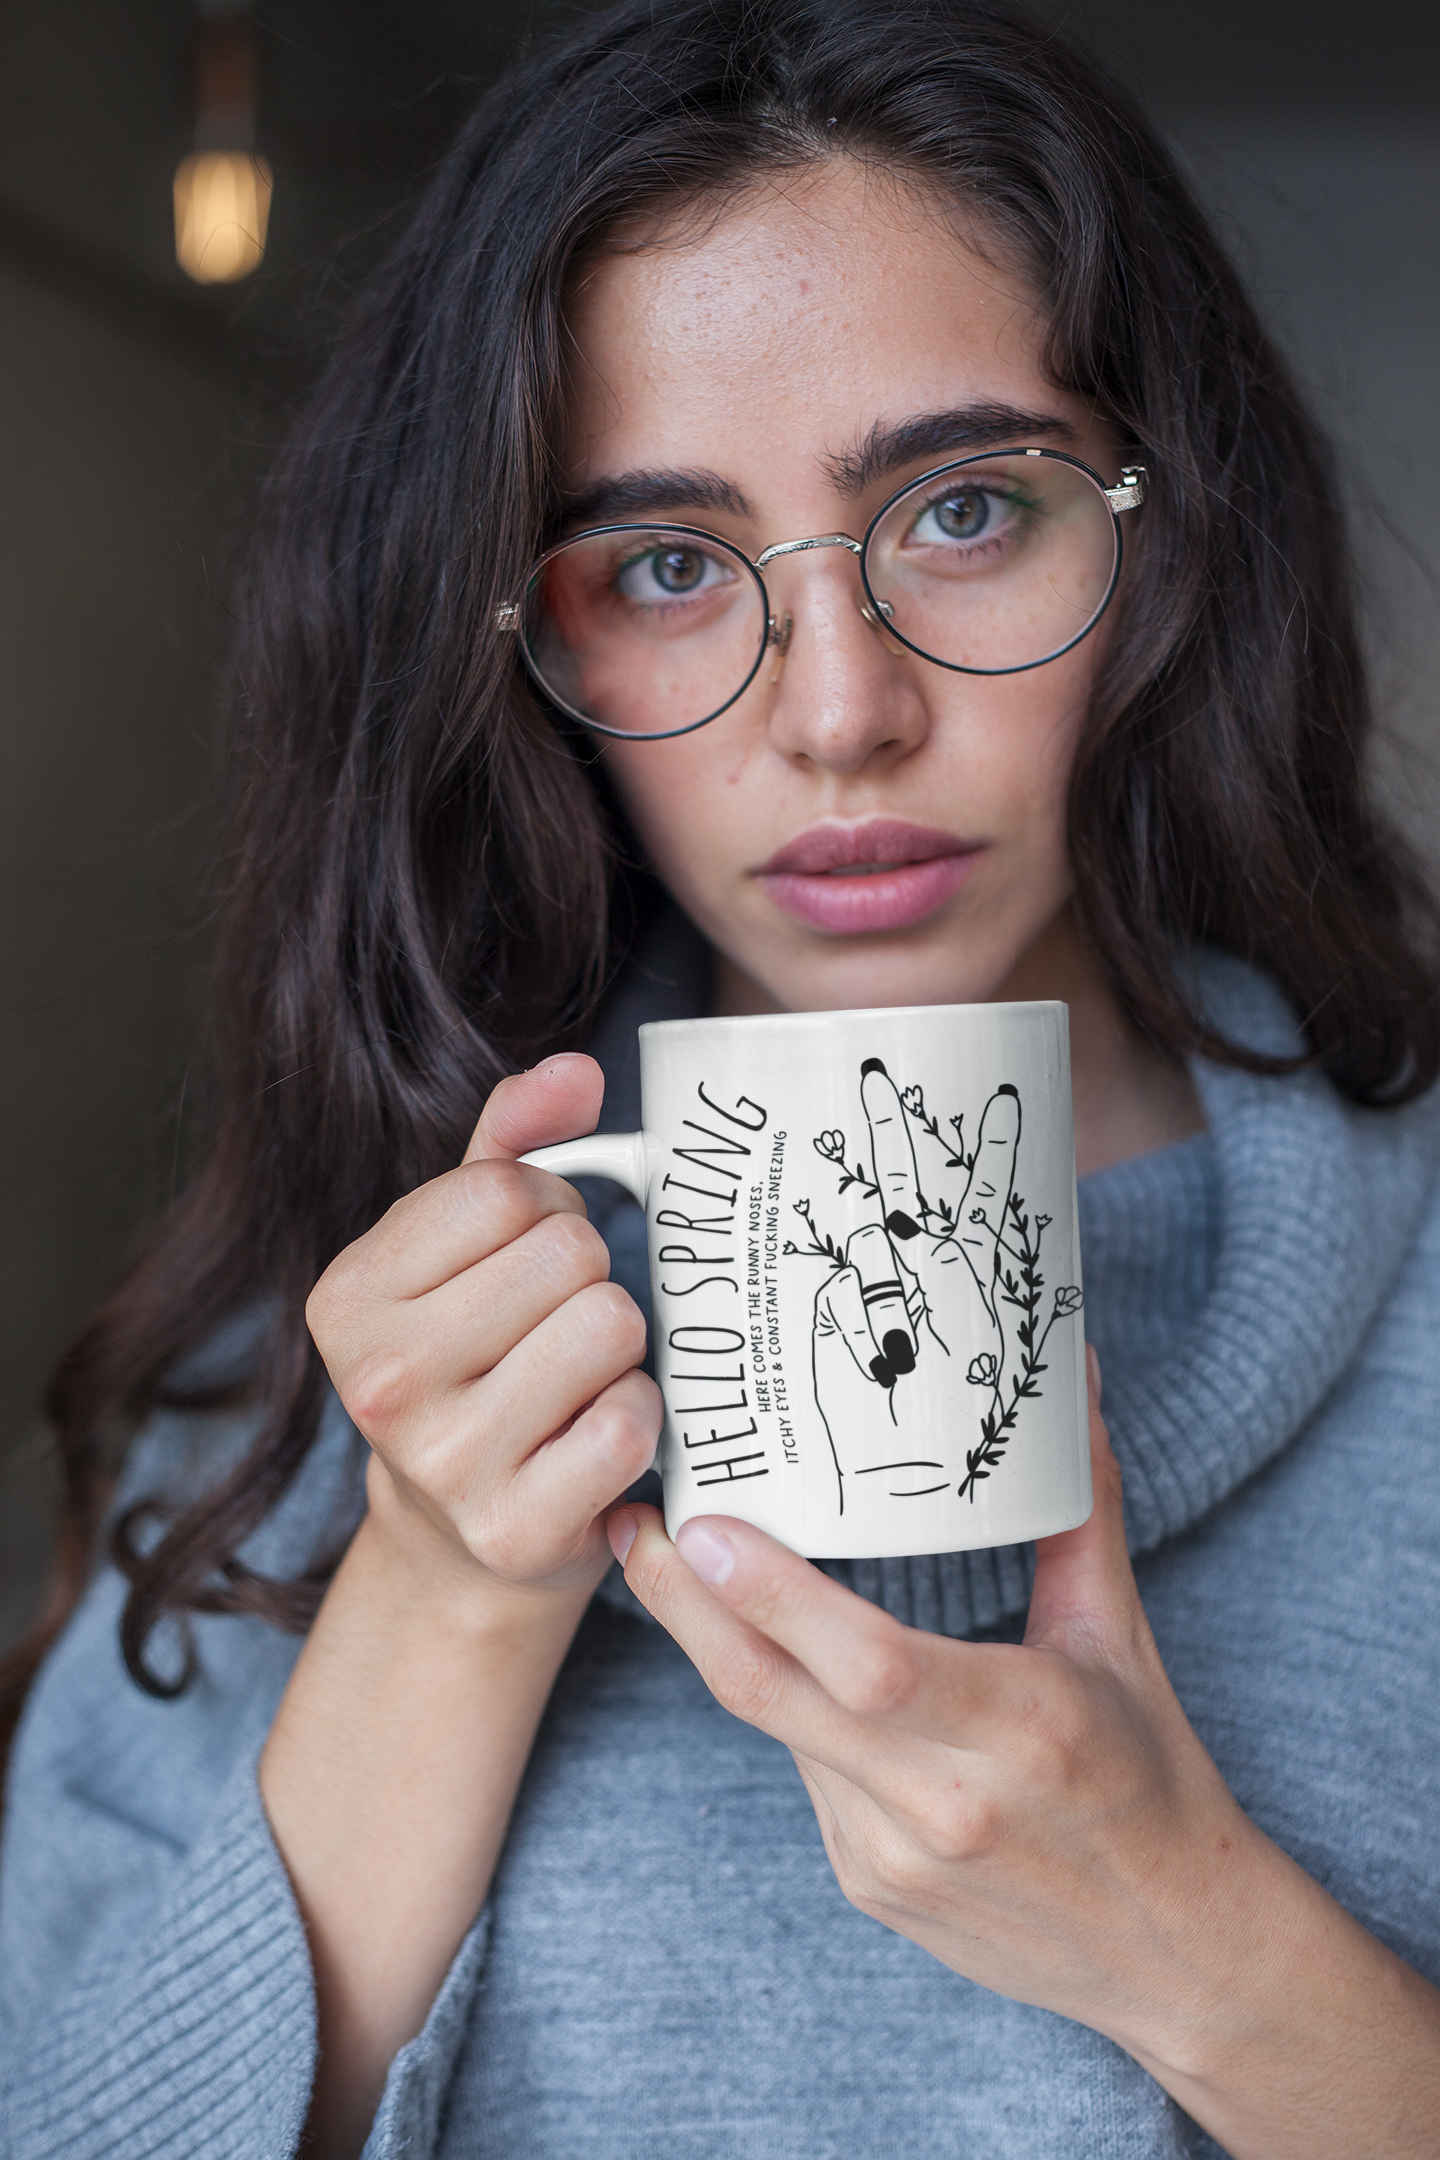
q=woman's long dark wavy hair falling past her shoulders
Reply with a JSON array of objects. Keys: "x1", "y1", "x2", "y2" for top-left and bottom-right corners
[{"x1": 11, "y1": 0, "x2": 1440, "y2": 1719}]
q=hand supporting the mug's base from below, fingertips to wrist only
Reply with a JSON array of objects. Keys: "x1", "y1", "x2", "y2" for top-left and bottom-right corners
[{"x1": 611, "y1": 1347, "x2": 1246, "y2": 2030}]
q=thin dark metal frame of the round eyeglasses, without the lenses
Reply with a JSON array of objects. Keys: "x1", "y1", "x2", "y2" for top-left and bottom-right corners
[{"x1": 497, "y1": 443, "x2": 1146, "y2": 743}]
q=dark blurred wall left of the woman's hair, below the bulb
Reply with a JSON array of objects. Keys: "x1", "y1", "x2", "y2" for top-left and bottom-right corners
[{"x1": 0, "y1": 270, "x2": 225, "y2": 1624}]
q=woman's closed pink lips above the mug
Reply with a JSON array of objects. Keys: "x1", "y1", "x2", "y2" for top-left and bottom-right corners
[{"x1": 753, "y1": 819, "x2": 982, "y2": 937}]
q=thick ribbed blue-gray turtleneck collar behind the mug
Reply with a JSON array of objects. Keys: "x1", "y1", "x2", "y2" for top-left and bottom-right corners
[{"x1": 587, "y1": 914, "x2": 1440, "y2": 1635}]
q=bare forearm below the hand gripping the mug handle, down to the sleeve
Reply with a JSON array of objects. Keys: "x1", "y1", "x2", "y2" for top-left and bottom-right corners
[{"x1": 261, "y1": 1469, "x2": 609, "y2": 2156}]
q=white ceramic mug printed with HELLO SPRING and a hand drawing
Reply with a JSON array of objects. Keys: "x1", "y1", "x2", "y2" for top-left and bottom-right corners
[{"x1": 525, "y1": 1004, "x2": 1090, "y2": 1557}]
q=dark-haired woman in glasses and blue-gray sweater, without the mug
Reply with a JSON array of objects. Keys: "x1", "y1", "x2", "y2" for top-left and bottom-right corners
[{"x1": 4, "y1": 0, "x2": 1440, "y2": 2160}]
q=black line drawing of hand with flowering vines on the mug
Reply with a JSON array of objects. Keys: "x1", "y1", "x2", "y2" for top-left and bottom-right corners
[{"x1": 786, "y1": 1058, "x2": 1082, "y2": 1514}]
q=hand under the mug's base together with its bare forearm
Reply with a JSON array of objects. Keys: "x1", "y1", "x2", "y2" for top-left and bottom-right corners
[{"x1": 609, "y1": 1352, "x2": 1440, "y2": 2160}]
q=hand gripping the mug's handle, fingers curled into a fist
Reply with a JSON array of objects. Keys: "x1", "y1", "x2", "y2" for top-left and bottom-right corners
[{"x1": 307, "y1": 1056, "x2": 661, "y2": 1601}]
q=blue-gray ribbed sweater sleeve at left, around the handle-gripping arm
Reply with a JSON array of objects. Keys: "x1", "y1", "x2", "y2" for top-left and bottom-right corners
[{"x1": 0, "y1": 1399, "x2": 486, "y2": 2160}]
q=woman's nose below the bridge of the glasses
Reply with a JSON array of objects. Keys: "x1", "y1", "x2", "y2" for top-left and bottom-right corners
[{"x1": 760, "y1": 551, "x2": 930, "y2": 773}]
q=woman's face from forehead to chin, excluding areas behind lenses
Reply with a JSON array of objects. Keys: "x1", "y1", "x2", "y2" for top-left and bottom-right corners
[{"x1": 566, "y1": 162, "x2": 1118, "y2": 1011}]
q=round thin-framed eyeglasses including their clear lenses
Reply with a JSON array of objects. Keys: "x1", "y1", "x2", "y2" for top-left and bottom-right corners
[{"x1": 499, "y1": 449, "x2": 1144, "y2": 741}]
